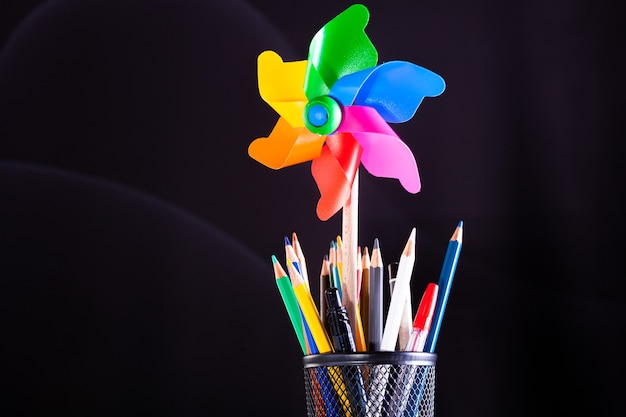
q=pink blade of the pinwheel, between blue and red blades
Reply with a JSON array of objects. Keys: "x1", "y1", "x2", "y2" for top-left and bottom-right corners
[{"x1": 337, "y1": 106, "x2": 421, "y2": 194}]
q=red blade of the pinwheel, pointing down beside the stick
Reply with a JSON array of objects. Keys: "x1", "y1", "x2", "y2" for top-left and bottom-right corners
[{"x1": 311, "y1": 133, "x2": 363, "y2": 220}]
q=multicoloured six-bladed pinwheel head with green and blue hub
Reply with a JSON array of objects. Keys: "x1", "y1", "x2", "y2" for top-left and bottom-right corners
[{"x1": 248, "y1": 4, "x2": 445, "y2": 220}]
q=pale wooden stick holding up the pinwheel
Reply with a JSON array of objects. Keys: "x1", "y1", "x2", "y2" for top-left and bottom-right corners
[{"x1": 341, "y1": 170, "x2": 362, "y2": 350}]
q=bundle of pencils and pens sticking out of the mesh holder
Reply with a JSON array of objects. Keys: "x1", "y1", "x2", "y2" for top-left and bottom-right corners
[{"x1": 272, "y1": 221, "x2": 463, "y2": 355}]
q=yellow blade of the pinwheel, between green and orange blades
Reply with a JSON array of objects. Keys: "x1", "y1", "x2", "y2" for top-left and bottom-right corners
[{"x1": 257, "y1": 51, "x2": 307, "y2": 128}]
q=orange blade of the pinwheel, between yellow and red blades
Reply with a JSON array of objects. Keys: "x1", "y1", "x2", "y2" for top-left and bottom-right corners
[{"x1": 248, "y1": 117, "x2": 326, "y2": 169}]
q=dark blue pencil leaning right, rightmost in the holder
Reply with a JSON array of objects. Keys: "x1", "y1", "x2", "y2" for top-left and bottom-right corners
[{"x1": 424, "y1": 220, "x2": 463, "y2": 353}]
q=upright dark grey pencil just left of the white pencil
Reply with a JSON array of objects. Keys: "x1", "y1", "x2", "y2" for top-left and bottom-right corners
[{"x1": 368, "y1": 238, "x2": 384, "y2": 352}]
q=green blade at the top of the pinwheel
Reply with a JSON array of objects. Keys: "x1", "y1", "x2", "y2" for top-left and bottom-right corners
[{"x1": 304, "y1": 4, "x2": 378, "y2": 100}]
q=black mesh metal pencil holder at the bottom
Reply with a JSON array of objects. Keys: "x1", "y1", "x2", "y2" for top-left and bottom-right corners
[{"x1": 302, "y1": 352, "x2": 437, "y2": 417}]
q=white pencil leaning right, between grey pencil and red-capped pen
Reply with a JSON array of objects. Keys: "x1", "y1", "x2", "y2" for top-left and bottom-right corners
[{"x1": 380, "y1": 228, "x2": 416, "y2": 351}]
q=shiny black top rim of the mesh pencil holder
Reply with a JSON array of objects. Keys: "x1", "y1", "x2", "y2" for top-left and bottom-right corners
[{"x1": 302, "y1": 352, "x2": 437, "y2": 368}]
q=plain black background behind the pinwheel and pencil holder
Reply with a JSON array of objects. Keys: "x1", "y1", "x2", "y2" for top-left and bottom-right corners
[{"x1": 0, "y1": 0, "x2": 626, "y2": 417}]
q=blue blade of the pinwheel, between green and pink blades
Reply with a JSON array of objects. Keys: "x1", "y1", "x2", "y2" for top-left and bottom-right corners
[{"x1": 329, "y1": 61, "x2": 446, "y2": 123}]
